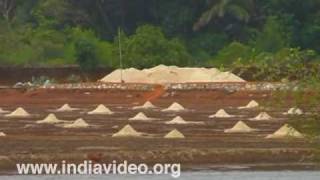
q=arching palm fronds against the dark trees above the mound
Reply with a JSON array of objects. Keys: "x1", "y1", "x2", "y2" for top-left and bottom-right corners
[{"x1": 193, "y1": 0, "x2": 254, "y2": 31}]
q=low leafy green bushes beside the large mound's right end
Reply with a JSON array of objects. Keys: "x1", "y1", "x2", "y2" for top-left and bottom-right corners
[{"x1": 233, "y1": 48, "x2": 320, "y2": 81}]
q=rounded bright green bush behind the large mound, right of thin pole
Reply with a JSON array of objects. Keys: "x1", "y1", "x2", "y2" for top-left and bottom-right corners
[{"x1": 122, "y1": 25, "x2": 190, "y2": 68}]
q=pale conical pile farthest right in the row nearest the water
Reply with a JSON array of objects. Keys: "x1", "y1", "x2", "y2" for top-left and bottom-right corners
[{"x1": 266, "y1": 124, "x2": 303, "y2": 138}]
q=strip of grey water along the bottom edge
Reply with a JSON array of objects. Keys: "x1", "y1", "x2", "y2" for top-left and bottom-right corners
[{"x1": 0, "y1": 171, "x2": 320, "y2": 180}]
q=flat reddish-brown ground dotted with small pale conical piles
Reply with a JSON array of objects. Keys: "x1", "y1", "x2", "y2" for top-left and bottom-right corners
[{"x1": 0, "y1": 87, "x2": 314, "y2": 173}]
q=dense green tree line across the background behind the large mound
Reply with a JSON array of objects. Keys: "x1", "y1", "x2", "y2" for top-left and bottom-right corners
[{"x1": 0, "y1": 0, "x2": 320, "y2": 78}]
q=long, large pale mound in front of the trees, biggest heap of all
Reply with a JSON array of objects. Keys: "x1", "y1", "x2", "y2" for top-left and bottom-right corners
[{"x1": 100, "y1": 65, "x2": 245, "y2": 84}]
